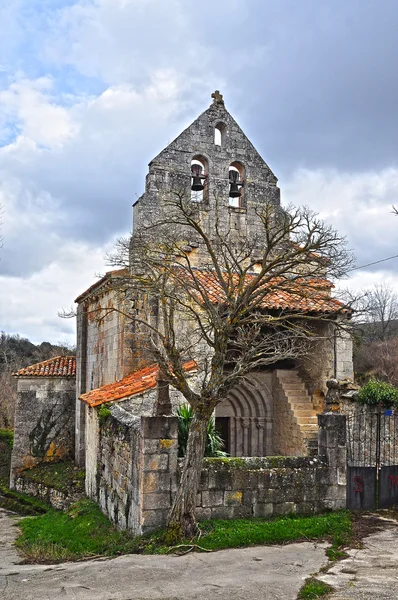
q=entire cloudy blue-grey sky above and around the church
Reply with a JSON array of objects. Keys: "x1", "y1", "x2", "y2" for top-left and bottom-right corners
[{"x1": 0, "y1": 0, "x2": 398, "y2": 343}]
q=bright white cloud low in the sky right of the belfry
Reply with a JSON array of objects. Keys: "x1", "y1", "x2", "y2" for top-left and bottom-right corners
[{"x1": 281, "y1": 168, "x2": 398, "y2": 293}]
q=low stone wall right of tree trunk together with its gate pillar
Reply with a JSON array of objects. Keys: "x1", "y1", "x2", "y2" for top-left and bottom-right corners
[{"x1": 192, "y1": 414, "x2": 347, "y2": 519}]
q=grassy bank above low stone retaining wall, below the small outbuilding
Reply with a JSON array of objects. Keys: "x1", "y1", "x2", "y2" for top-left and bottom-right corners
[{"x1": 18, "y1": 461, "x2": 85, "y2": 494}]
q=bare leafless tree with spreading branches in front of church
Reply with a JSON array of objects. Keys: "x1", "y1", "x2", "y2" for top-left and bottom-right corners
[{"x1": 105, "y1": 192, "x2": 352, "y2": 541}]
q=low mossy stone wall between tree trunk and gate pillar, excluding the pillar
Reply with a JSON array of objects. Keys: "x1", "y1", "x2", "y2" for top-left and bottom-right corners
[{"x1": 196, "y1": 457, "x2": 336, "y2": 519}]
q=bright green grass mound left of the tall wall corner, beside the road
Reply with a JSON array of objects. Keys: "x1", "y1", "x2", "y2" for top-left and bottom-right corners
[{"x1": 16, "y1": 500, "x2": 138, "y2": 563}]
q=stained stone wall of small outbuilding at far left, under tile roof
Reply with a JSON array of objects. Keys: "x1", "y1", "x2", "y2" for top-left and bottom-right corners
[{"x1": 10, "y1": 377, "x2": 76, "y2": 488}]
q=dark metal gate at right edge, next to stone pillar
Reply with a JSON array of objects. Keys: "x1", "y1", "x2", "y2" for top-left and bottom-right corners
[{"x1": 347, "y1": 406, "x2": 398, "y2": 510}]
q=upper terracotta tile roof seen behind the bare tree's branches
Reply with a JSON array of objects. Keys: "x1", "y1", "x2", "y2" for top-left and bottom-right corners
[{"x1": 186, "y1": 269, "x2": 349, "y2": 314}]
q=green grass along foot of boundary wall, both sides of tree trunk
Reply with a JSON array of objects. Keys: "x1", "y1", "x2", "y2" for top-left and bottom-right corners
[{"x1": 17, "y1": 500, "x2": 351, "y2": 563}]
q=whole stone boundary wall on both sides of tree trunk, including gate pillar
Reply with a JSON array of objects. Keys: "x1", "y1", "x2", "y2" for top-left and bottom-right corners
[{"x1": 86, "y1": 409, "x2": 347, "y2": 535}]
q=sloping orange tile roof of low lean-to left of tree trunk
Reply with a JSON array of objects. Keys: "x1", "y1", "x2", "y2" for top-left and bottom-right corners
[{"x1": 79, "y1": 360, "x2": 196, "y2": 407}]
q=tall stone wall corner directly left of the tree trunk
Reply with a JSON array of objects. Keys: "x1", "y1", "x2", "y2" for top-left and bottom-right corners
[{"x1": 86, "y1": 412, "x2": 178, "y2": 535}]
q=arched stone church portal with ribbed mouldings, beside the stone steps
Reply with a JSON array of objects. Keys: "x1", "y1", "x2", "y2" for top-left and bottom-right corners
[{"x1": 216, "y1": 373, "x2": 272, "y2": 456}]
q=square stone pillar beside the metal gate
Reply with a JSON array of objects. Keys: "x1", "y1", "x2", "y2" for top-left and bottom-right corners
[{"x1": 318, "y1": 412, "x2": 347, "y2": 510}]
